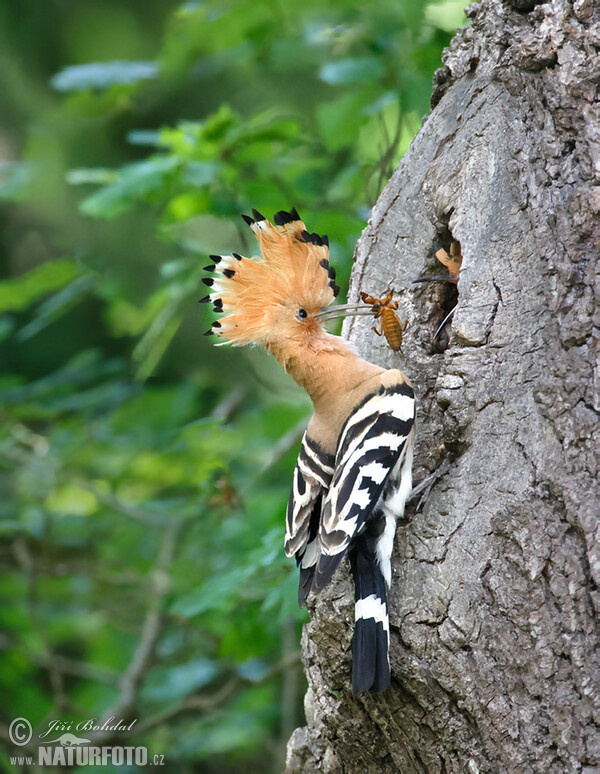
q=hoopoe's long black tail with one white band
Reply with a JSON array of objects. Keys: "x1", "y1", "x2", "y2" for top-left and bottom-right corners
[{"x1": 349, "y1": 518, "x2": 390, "y2": 695}]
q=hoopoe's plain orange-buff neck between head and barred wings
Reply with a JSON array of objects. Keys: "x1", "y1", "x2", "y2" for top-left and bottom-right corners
[{"x1": 267, "y1": 332, "x2": 383, "y2": 413}]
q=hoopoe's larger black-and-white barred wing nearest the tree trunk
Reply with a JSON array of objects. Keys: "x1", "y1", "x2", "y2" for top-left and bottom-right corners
[{"x1": 312, "y1": 382, "x2": 415, "y2": 593}]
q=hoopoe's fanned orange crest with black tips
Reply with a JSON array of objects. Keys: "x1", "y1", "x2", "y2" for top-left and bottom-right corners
[{"x1": 202, "y1": 207, "x2": 339, "y2": 346}]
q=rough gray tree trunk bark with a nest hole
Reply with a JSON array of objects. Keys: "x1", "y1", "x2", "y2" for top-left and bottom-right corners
[{"x1": 287, "y1": 0, "x2": 600, "y2": 774}]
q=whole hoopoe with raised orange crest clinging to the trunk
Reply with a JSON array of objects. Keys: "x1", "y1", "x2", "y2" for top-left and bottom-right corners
[{"x1": 202, "y1": 208, "x2": 415, "y2": 694}]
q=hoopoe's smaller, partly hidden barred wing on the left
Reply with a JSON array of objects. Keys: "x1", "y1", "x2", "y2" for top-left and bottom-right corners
[{"x1": 285, "y1": 433, "x2": 334, "y2": 607}]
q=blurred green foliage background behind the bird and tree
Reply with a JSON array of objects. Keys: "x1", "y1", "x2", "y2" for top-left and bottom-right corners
[{"x1": 0, "y1": 0, "x2": 464, "y2": 774}]
